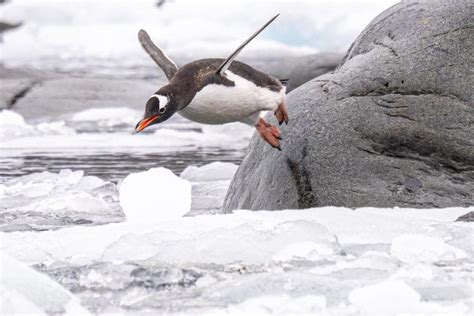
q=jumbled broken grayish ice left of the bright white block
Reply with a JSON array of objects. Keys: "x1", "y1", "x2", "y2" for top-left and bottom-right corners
[{"x1": 0, "y1": 169, "x2": 123, "y2": 231}]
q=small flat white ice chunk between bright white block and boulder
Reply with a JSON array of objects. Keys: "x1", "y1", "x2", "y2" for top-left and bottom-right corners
[{"x1": 180, "y1": 161, "x2": 238, "y2": 182}]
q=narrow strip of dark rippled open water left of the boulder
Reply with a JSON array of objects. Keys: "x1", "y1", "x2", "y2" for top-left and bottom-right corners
[{"x1": 0, "y1": 147, "x2": 244, "y2": 183}]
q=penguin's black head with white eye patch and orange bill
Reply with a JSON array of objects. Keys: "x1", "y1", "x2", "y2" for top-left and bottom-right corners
[{"x1": 135, "y1": 90, "x2": 178, "y2": 133}]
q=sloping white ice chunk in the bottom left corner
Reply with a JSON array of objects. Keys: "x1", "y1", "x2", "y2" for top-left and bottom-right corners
[{"x1": 0, "y1": 253, "x2": 89, "y2": 315}]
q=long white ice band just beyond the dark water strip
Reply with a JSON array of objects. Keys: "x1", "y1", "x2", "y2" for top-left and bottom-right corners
[{"x1": 0, "y1": 115, "x2": 254, "y2": 152}]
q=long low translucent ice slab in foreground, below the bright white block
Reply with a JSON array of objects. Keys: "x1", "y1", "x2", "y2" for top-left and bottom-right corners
[{"x1": 104, "y1": 218, "x2": 340, "y2": 264}]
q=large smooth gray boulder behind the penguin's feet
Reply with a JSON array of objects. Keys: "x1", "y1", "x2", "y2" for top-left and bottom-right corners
[{"x1": 224, "y1": 0, "x2": 474, "y2": 211}]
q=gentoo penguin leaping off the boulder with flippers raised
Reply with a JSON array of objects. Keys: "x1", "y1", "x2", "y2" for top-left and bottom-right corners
[{"x1": 135, "y1": 14, "x2": 288, "y2": 150}]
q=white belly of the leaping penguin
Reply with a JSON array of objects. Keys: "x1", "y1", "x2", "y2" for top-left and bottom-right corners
[{"x1": 178, "y1": 71, "x2": 285, "y2": 124}]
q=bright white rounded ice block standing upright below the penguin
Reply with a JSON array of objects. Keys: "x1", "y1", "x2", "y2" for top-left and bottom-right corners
[{"x1": 120, "y1": 168, "x2": 191, "y2": 222}]
